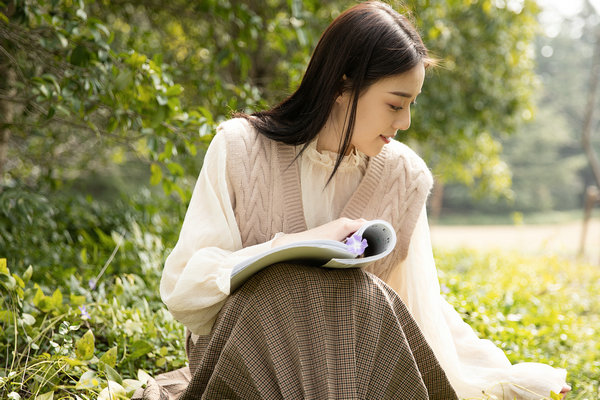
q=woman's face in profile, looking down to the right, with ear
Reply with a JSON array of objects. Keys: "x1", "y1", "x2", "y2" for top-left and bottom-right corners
[{"x1": 337, "y1": 63, "x2": 425, "y2": 157}]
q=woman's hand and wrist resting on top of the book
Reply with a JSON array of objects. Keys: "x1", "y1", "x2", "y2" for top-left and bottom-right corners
[{"x1": 271, "y1": 218, "x2": 367, "y2": 247}]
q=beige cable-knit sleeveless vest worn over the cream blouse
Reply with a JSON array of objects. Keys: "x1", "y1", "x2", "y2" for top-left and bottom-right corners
[{"x1": 217, "y1": 118, "x2": 433, "y2": 281}]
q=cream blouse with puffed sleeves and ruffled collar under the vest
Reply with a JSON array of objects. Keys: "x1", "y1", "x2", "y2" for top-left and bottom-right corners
[{"x1": 160, "y1": 135, "x2": 566, "y2": 399}]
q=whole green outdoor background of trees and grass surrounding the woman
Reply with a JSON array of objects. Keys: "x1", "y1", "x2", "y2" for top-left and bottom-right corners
[{"x1": 0, "y1": 0, "x2": 600, "y2": 399}]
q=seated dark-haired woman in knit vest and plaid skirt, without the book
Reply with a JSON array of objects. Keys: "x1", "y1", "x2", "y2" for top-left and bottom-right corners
[{"x1": 154, "y1": 2, "x2": 569, "y2": 399}]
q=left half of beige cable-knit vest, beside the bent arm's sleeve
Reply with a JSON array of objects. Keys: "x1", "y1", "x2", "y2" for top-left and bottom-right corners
[{"x1": 224, "y1": 118, "x2": 306, "y2": 247}]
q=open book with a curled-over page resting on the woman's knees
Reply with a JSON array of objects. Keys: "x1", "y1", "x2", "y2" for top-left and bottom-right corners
[{"x1": 230, "y1": 220, "x2": 396, "y2": 293}]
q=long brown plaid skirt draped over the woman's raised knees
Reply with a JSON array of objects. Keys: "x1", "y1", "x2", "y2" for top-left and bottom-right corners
[{"x1": 181, "y1": 263, "x2": 456, "y2": 400}]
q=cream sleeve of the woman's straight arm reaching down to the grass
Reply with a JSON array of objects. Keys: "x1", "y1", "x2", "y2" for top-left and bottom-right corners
[{"x1": 387, "y1": 208, "x2": 566, "y2": 399}]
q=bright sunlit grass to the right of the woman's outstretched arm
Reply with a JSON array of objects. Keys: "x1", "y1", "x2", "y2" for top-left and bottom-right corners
[{"x1": 436, "y1": 250, "x2": 600, "y2": 399}]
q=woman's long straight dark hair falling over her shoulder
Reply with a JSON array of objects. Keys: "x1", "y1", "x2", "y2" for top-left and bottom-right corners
[{"x1": 241, "y1": 1, "x2": 433, "y2": 180}]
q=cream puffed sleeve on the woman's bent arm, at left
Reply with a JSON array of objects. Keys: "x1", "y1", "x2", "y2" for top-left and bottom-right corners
[{"x1": 160, "y1": 133, "x2": 278, "y2": 335}]
